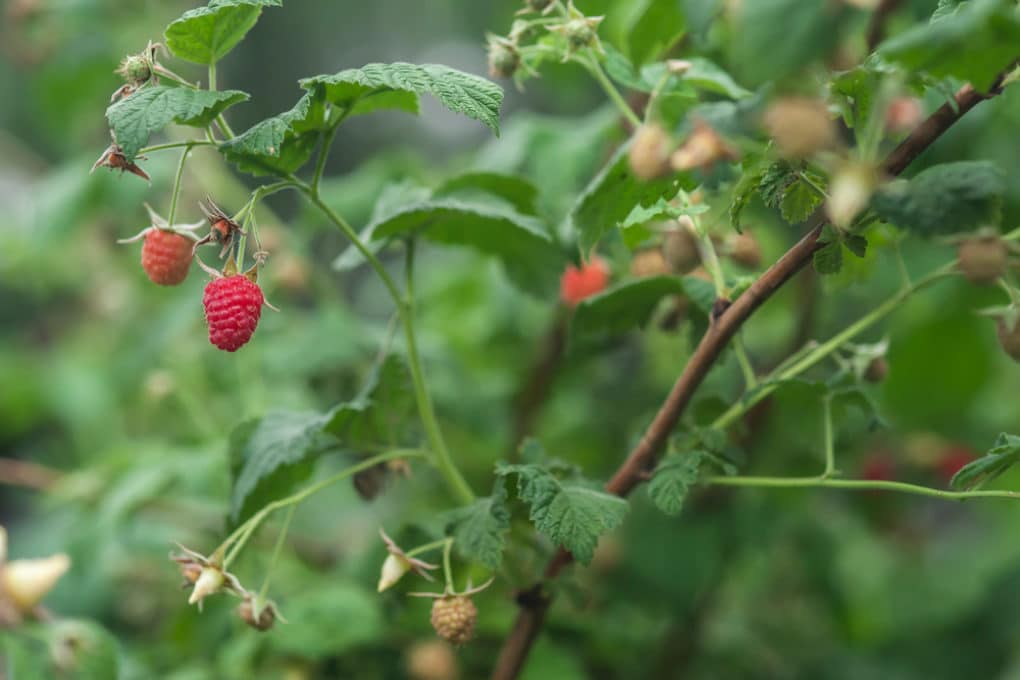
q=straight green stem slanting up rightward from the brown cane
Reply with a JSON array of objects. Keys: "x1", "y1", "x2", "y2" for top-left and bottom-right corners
[{"x1": 710, "y1": 262, "x2": 956, "y2": 429}]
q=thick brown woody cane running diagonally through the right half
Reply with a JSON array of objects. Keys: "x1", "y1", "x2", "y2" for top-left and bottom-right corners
[{"x1": 492, "y1": 69, "x2": 1005, "y2": 680}]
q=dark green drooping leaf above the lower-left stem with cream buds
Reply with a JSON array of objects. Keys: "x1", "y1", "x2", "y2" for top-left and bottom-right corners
[{"x1": 228, "y1": 411, "x2": 328, "y2": 525}]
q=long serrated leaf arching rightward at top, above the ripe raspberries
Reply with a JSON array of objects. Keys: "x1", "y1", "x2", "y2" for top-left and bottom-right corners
[{"x1": 301, "y1": 62, "x2": 503, "y2": 135}]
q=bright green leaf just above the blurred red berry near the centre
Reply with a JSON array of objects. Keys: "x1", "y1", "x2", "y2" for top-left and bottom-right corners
[{"x1": 570, "y1": 143, "x2": 694, "y2": 252}]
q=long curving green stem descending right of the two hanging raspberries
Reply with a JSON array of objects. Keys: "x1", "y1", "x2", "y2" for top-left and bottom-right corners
[{"x1": 291, "y1": 176, "x2": 474, "y2": 505}]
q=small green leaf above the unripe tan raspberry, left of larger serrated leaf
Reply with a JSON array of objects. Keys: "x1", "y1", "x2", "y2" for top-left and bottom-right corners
[{"x1": 447, "y1": 477, "x2": 510, "y2": 571}]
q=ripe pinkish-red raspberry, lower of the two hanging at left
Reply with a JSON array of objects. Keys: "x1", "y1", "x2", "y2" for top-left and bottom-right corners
[{"x1": 202, "y1": 274, "x2": 265, "y2": 352}]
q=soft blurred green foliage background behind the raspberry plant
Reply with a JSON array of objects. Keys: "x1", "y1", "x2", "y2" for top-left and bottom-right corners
[{"x1": 0, "y1": 0, "x2": 1020, "y2": 680}]
